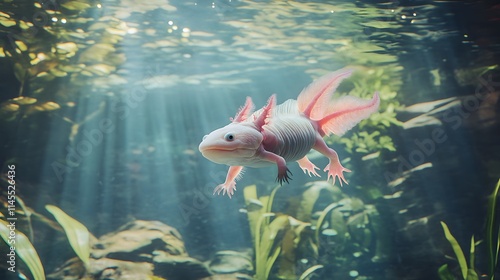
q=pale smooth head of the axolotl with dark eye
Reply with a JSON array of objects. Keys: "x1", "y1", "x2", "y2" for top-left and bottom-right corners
[{"x1": 198, "y1": 122, "x2": 263, "y2": 166}]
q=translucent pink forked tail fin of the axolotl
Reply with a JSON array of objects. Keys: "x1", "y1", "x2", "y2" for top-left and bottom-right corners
[{"x1": 297, "y1": 68, "x2": 380, "y2": 136}]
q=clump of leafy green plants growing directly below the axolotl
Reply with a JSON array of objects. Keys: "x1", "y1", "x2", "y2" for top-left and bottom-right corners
[{"x1": 244, "y1": 181, "x2": 384, "y2": 279}]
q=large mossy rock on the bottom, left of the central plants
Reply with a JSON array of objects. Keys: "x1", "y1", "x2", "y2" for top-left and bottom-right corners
[{"x1": 48, "y1": 220, "x2": 214, "y2": 280}]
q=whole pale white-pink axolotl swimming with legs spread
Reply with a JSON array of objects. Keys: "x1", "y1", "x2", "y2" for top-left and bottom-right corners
[{"x1": 199, "y1": 69, "x2": 380, "y2": 197}]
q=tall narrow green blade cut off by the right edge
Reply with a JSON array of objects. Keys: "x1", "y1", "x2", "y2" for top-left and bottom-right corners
[{"x1": 486, "y1": 180, "x2": 500, "y2": 280}]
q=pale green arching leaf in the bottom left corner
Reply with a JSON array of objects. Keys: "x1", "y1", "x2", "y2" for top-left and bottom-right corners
[{"x1": 0, "y1": 220, "x2": 45, "y2": 280}]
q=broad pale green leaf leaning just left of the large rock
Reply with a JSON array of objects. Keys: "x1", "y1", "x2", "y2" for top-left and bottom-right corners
[{"x1": 45, "y1": 205, "x2": 90, "y2": 267}]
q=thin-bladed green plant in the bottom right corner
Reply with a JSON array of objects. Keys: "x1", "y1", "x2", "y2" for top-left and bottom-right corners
[{"x1": 438, "y1": 180, "x2": 500, "y2": 280}]
